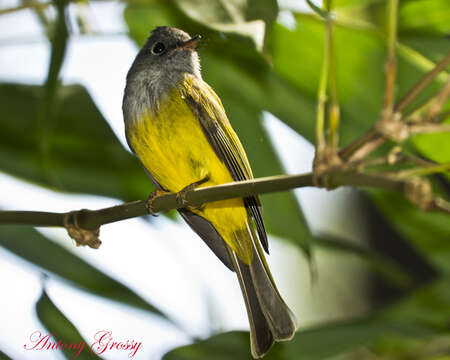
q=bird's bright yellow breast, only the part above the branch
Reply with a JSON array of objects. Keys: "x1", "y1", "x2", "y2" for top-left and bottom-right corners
[{"x1": 129, "y1": 89, "x2": 233, "y2": 192}]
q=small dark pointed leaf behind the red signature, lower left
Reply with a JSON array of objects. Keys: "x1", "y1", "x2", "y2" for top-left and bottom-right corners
[{"x1": 35, "y1": 291, "x2": 100, "y2": 360}]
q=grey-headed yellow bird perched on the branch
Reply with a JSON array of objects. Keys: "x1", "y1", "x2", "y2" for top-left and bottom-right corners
[{"x1": 122, "y1": 26, "x2": 296, "y2": 358}]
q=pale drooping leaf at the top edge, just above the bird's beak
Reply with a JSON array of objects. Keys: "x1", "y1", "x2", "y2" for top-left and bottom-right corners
[{"x1": 175, "y1": 0, "x2": 278, "y2": 51}]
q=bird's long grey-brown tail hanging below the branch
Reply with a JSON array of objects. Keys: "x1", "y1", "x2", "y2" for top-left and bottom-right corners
[{"x1": 228, "y1": 225, "x2": 295, "y2": 358}]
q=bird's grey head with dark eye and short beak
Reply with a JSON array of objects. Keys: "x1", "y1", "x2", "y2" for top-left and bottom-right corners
[{"x1": 124, "y1": 26, "x2": 201, "y2": 116}]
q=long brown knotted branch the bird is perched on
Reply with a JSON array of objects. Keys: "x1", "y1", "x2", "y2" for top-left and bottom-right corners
[{"x1": 0, "y1": 168, "x2": 450, "y2": 248}]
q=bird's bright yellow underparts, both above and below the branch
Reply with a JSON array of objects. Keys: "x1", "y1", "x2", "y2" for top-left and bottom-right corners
[{"x1": 128, "y1": 86, "x2": 252, "y2": 263}]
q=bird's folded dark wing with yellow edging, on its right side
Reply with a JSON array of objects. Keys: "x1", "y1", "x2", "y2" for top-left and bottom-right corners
[{"x1": 182, "y1": 76, "x2": 269, "y2": 253}]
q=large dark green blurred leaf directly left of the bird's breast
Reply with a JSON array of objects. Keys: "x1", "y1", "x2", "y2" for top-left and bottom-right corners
[{"x1": 0, "y1": 84, "x2": 153, "y2": 201}]
